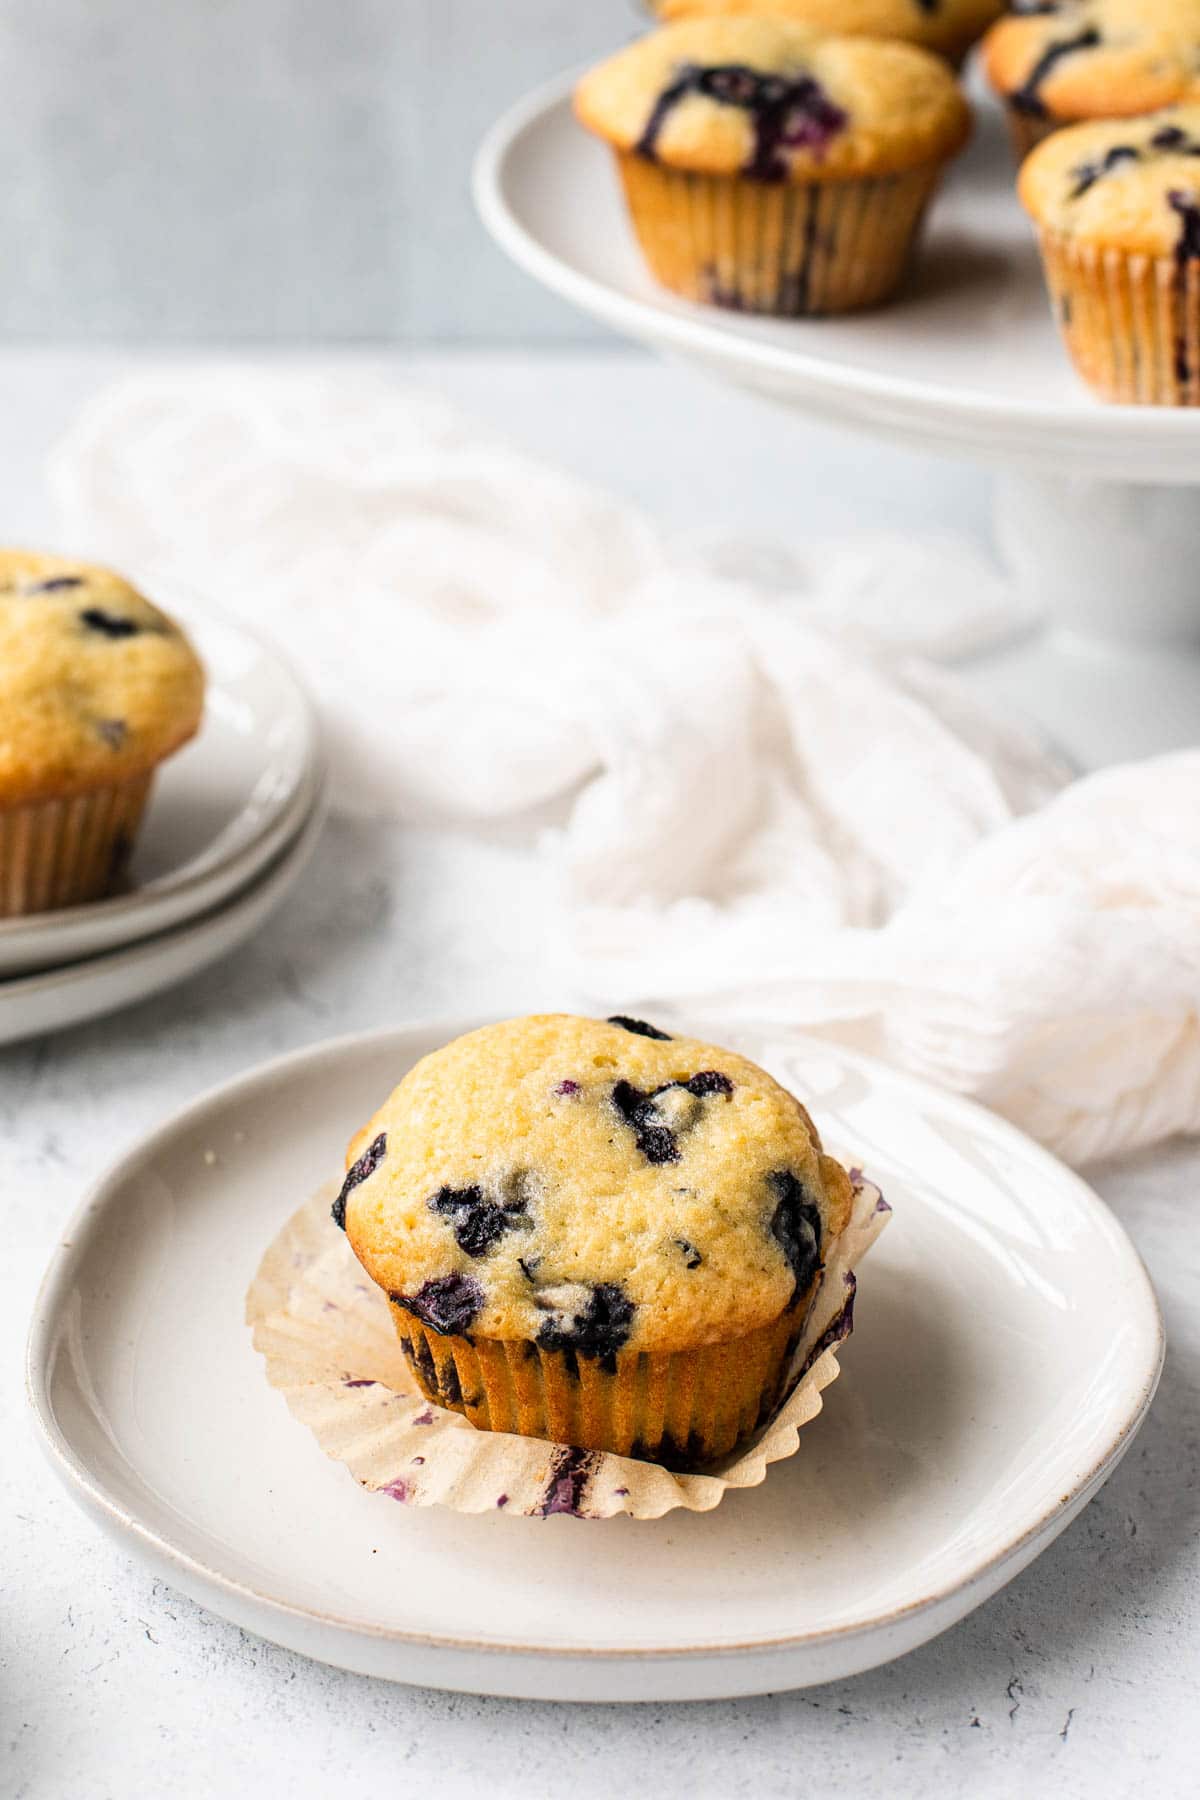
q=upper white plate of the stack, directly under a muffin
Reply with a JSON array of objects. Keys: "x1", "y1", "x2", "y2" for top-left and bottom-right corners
[{"x1": 0, "y1": 601, "x2": 320, "y2": 977}]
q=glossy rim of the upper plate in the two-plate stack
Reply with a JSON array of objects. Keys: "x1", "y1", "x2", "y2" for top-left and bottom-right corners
[{"x1": 0, "y1": 597, "x2": 324, "y2": 957}]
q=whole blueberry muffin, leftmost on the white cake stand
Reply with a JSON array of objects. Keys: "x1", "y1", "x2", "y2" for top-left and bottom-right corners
[{"x1": 576, "y1": 14, "x2": 970, "y2": 317}]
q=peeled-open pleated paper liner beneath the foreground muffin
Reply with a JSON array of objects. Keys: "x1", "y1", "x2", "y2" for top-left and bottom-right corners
[{"x1": 246, "y1": 1177, "x2": 891, "y2": 1519}]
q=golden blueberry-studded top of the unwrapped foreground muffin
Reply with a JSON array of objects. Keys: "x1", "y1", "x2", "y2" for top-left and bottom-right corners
[{"x1": 333, "y1": 1013, "x2": 853, "y2": 1361}]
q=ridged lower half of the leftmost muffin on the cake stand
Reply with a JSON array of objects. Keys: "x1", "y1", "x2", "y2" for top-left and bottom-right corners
[{"x1": 617, "y1": 151, "x2": 943, "y2": 319}]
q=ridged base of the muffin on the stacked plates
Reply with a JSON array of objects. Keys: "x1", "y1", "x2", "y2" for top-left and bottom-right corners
[{"x1": 0, "y1": 770, "x2": 155, "y2": 918}]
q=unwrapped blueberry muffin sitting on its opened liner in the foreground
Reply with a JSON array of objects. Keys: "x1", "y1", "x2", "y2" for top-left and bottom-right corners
[{"x1": 333, "y1": 1015, "x2": 853, "y2": 1463}]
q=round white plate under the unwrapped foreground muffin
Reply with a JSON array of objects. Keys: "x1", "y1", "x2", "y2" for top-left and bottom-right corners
[{"x1": 29, "y1": 1022, "x2": 1162, "y2": 1701}]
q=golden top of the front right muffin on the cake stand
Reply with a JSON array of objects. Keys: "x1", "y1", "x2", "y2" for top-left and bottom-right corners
[{"x1": 1016, "y1": 106, "x2": 1200, "y2": 261}]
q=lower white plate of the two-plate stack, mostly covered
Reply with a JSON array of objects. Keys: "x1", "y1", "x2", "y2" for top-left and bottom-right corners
[{"x1": 0, "y1": 787, "x2": 324, "y2": 1044}]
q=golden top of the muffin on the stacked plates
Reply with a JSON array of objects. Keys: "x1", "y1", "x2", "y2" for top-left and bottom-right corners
[{"x1": 0, "y1": 551, "x2": 203, "y2": 806}]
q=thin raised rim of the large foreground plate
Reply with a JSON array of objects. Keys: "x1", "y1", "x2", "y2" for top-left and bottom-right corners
[{"x1": 25, "y1": 1015, "x2": 1166, "y2": 1665}]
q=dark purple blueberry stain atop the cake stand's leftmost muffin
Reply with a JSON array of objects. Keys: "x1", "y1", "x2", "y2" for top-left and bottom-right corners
[{"x1": 637, "y1": 63, "x2": 849, "y2": 182}]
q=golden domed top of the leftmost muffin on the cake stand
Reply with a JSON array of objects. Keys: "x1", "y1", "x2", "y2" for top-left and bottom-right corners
[{"x1": 576, "y1": 14, "x2": 970, "y2": 182}]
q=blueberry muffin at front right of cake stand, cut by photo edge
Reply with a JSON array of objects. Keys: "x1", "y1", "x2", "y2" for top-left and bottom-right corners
[{"x1": 1018, "y1": 106, "x2": 1200, "y2": 407}]
